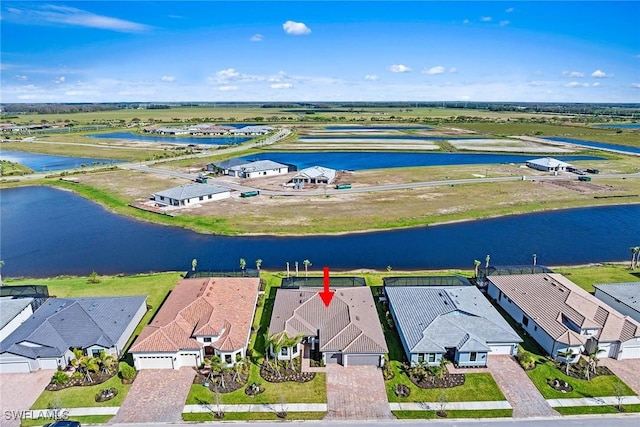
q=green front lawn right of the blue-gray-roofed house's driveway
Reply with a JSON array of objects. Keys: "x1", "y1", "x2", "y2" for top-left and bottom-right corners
[{"x1": 527, "y1": 362, "x2": 636, "y2": 399}]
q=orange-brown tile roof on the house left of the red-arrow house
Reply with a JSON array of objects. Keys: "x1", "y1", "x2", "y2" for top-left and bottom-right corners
[{"x1": 130, "y1": 277, "x2": 260, "y2": 353}]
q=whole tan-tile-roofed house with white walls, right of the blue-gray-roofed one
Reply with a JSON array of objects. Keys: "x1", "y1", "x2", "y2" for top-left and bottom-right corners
[{"x1": 487, "y1": 273, "x2": 640, "y2": 361}]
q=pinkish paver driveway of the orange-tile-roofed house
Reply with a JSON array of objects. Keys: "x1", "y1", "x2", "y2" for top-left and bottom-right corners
[{"x1": 111, "y1": 368, "x2": 195, "y2": 423}]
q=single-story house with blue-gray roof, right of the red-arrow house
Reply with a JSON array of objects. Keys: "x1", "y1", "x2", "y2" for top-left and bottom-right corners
[{"x1": 384, "y1": 286, "x2": 522, "y2": 366}]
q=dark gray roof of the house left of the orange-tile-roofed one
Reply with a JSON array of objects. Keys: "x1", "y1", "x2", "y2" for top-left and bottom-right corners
[{"x1": 0, "y1": 296, "x2": 147, "y2": 358}]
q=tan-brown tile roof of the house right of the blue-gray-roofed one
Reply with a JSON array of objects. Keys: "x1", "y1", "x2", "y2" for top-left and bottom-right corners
[{"x1": 489, "y1": 273, "x2": 640, "y2": 344}]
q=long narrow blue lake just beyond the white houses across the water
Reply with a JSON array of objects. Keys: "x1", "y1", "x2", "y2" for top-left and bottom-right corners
[{"x1": 241, "y1": 151, "x2": 602, "y2": 170}]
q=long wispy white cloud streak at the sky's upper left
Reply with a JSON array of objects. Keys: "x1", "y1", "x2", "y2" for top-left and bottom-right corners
[{"x1": 8, "y1": 4, "x2": 151, "y2": 33}]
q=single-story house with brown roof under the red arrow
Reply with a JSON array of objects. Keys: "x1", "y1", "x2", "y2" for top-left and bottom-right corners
[{"x1": 269, "y1": 286, "x2": 388, "y2": 366}]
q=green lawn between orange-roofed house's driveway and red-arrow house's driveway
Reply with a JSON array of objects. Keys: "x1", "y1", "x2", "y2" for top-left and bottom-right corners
[{"x1": 186, "y1": 365, "x2": 327, "y2": 405}]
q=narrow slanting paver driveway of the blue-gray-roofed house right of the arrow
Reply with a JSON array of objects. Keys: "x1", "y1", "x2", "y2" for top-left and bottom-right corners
[{"x1": 487, "y1": 355, "x2": 559, "y2": 418}]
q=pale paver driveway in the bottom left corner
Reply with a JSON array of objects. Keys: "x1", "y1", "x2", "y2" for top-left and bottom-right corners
[{"x1": 0, "y1": 369, "x2": 55, "y2": 427}]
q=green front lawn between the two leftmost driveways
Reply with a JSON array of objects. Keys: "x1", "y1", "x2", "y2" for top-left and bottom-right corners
[{"x1": 31, "y1": 375, "x2": 131, "y2": 409}]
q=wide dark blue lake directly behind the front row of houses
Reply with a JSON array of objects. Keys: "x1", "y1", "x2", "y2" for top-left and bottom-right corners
[{"x1": 0, "y1": 187, "x2": 640, "y2": 277}]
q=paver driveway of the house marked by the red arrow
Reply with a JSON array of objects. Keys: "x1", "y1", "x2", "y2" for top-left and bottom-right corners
[{"x1": 325, "y1": 364, "x2": 394, "y2": 420}]
